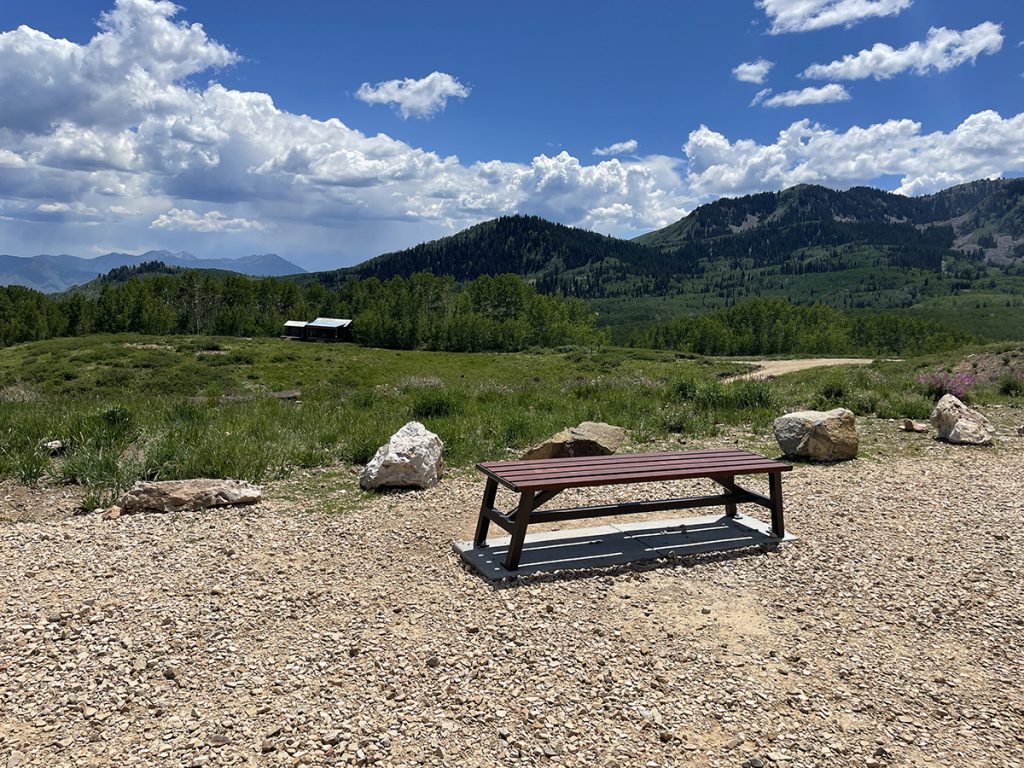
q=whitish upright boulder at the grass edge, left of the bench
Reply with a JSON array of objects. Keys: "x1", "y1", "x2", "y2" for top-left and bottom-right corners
[{"x1": 359, "y1": 421, "x2": 444, "y2": 490}]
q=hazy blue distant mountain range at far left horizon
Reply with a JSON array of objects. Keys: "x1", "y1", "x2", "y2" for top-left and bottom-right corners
[{"x1": 0, "y1": 251, "x2": 306, "y2": 293}]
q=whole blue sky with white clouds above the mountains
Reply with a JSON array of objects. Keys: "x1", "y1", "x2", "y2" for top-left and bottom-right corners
[{"x1": 0, "y1": 0, "x2": 1024, "y2": 269}]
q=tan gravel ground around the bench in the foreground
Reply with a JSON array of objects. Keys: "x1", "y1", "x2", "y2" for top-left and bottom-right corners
[{"x1": 0, "y1": 411, "x2": 1024, "y2": 768}]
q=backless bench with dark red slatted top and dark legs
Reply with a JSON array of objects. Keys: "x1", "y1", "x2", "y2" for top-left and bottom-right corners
[{"x1": 473, "y1": 449, "x2": 793, "y2": 570}]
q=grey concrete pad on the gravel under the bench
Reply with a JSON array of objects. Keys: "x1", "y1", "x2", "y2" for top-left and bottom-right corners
[{"x1": 453, "y1": 515, "x2": 797, "y2": 581}]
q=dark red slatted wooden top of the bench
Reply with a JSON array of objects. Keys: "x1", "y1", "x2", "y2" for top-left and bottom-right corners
[{"x1": 476, "y1": 449, "x2": 793, "y2": 493}]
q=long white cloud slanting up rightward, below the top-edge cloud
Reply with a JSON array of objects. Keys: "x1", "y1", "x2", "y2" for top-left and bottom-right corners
[{"x1": 802, "y1": 22, "x2": 1004, "y2": 80}]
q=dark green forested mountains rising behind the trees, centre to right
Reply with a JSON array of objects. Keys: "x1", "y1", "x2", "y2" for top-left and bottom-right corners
[{"x1": 309, "y1": 179, "x2": 1024, "y2": 314}]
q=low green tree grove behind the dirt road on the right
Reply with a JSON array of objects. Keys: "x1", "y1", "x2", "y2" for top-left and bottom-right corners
[{"x1": 630, "y1": 299, "x2": 973, "y2": 355}]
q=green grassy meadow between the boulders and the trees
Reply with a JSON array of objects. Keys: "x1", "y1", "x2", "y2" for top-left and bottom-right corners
[{"x1": 0, "y1": 335, "x2": 1024, "y2": 508}]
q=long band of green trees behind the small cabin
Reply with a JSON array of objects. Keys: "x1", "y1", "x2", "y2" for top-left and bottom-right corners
[{"x1": 0, "y1": 267, "x2": 604, "y2": 351}]
